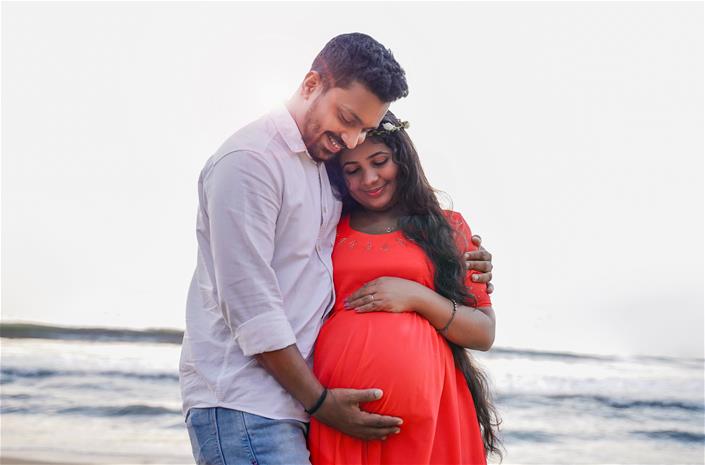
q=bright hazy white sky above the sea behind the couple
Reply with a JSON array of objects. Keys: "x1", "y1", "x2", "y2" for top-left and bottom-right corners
[{"x1": 2, "y1": 2, "x2": 703, "y2": 357}]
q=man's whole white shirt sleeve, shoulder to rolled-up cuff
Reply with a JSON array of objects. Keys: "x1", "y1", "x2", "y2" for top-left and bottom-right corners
[{"x1": 202, "y1": 151, "x2": 296, "y2": 356}]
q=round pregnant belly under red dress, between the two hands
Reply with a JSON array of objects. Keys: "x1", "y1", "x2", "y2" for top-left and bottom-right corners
[{"x1": 314, "y1": 310, "x2": 452, "y2": 423}]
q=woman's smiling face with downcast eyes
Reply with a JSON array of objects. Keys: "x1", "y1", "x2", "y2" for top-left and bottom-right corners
[{"x1": 340, "y1": 139, "x2": 399, "y2": 211}]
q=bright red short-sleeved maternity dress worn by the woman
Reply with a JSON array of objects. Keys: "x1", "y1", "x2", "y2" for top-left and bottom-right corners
[{"x1": 308, "y1": 212, "x2": 491, "y2": 465}]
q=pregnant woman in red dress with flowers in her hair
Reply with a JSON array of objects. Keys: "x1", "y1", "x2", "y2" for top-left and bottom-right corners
[{"x1": 308, "y1": 112, "x2": 501, "y2": 465}]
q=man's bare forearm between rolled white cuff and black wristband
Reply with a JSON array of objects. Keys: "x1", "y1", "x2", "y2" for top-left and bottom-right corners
[{"x1": 255, "y1": 344, "x2": 323, "y2": 408}]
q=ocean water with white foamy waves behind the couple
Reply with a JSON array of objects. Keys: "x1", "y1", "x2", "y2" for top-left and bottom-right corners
[{"x1": 0, "y1": 324, "x2": 705, "y2": 464}]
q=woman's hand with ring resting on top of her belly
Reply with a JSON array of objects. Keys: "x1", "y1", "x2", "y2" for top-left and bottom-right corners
[{"x1": 345, "y1": 276, "x2": 430, "y2": 313}]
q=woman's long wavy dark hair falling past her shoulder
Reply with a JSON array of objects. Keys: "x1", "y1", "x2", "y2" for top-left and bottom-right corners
[{"x1": 326, "y1": 111, "x2": 502, "y2": 460}]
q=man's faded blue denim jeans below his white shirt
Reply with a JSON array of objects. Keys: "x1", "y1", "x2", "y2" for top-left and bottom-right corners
[{"x1": 186, "y1": 407, "x2": 311, "y2": 465}]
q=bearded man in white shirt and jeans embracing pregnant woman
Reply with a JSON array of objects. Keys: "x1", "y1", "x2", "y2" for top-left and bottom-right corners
[{"x1": 180, "y1": 33, "x2": 491, "y2": 464}]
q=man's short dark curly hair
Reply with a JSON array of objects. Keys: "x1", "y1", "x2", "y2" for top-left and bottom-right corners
[{"x1": 311, "y1": 32, "x2": 409, "y2": 103}]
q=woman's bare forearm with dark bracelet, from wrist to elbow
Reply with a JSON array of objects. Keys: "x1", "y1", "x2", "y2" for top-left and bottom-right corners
[{"x1": 413, "y1": 286, "x2": 495, "y2": 351}]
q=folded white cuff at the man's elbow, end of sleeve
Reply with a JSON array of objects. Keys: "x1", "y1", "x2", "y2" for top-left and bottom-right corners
[{"x1": 235, "y1": 311, "x2": 296, "y2": 357}]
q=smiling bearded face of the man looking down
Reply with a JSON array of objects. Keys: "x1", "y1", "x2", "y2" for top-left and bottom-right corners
[{"x1": 302, "y1": 82, "x2": 389, "y2": 161}]
